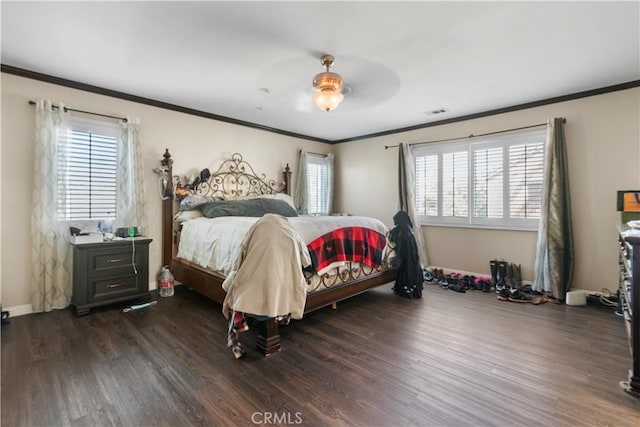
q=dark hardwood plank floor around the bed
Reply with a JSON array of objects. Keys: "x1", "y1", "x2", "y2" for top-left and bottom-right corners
[{"x1": 1, "y1": 285, "x2": 640, "y2": 427}]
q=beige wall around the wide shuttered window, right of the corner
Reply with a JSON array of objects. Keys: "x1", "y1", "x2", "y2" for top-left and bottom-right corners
[{"x1": 335, "y1": 88, "x2": 640, "y2": 292}]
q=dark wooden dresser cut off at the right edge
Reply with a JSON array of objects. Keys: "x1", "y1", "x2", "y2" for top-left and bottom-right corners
[{"x1": 618, "y1": 225, "x2": 640, "y2": 397}]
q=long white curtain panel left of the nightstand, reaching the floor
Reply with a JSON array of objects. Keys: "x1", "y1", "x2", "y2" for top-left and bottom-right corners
[{"x1": 31, "y1": 99, "x2": 72, "y2": 312}]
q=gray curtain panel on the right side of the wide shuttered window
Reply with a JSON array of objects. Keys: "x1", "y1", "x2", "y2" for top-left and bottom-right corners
[{"x1": 533, "y1": 118, "x2": 573, "y2": 301}]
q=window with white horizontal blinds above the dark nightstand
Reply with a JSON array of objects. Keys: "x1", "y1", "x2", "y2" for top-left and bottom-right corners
[{"x1": 57, "y1": 118, "x2": 121, "y2": 221}]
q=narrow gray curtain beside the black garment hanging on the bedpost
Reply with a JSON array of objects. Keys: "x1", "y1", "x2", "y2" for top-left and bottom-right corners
[{"x1": 398, "y1": 142, "x2": 429, "y2": 268}]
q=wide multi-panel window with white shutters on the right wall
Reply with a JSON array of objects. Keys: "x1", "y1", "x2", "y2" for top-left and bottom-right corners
[{"x1": 414, "y1": 129, "x2": 546, "y2": 230}]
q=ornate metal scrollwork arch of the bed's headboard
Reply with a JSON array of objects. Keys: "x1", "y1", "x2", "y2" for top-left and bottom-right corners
[{"x1": 176, "y1": 153, "x2": 288, "y2": 198}]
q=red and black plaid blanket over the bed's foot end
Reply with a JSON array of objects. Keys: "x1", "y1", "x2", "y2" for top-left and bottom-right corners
[{"x1": 307, "y1": 227, "x2": 387, "y2": 271}]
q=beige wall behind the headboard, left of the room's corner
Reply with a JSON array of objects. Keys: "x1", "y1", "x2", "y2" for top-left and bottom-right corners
[{"x1": 0, "y1": 73, "x2": 332, "y2": 315}]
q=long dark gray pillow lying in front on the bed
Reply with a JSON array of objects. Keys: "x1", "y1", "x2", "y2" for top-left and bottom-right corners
[{"x1": 200, "y1": 198, "x2": 298, "y2": 218}]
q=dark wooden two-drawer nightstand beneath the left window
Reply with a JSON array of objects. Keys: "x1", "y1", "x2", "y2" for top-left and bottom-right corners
[{"x1": 71, "y1": 237, "x2": 152, "y2": 316}]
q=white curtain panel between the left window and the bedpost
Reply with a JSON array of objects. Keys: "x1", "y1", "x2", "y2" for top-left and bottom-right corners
[{"x1": 114, "y1": 117, "x2": 147, "y2": 233}]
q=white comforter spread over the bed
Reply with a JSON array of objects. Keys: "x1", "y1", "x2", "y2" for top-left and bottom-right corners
[{"x1": 178, "y1": 216, "x2": 388, "y2": 276}]
